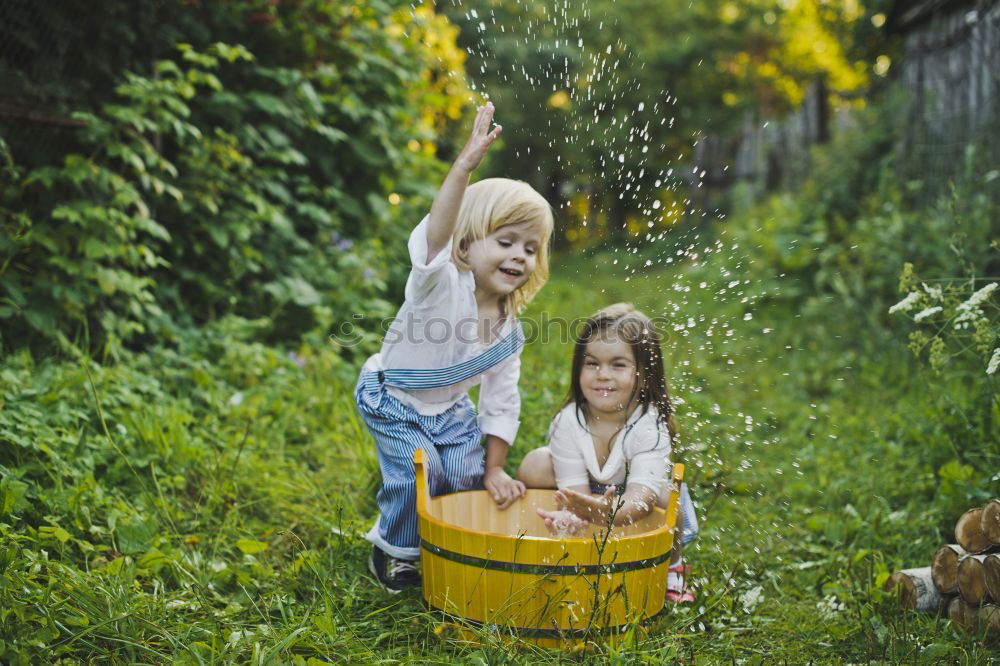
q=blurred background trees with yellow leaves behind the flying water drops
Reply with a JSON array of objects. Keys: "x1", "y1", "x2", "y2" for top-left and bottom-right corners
[{"x1": 448, "y1": 0, "x2": 886, "y2": 241}]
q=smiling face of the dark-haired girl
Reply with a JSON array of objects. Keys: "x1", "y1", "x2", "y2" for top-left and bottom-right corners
[{"x1": 580, "y1": 331, "x2": 638, "y2": 416}]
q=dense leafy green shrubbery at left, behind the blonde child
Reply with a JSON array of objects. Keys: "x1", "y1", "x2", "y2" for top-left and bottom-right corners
[{"x1": 0, "y1": 0, "x2": 465, "y2": 352}]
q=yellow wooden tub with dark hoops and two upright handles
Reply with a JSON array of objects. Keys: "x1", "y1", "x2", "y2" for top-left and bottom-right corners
[{"x1": 413, "y1": 449, "x2": 684, "y2": 647}]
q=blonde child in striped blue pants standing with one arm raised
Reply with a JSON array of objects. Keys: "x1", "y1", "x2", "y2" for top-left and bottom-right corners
[{"x1": 355, "y1": 103, "x2": 553, "y2": 592}]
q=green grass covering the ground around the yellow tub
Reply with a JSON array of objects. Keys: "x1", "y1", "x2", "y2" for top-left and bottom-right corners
[{"x1": 0, "y1": 233, "x2": 1000, "y2": 664}]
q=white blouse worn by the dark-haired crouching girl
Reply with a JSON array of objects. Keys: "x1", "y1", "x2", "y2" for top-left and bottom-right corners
[{"x1": 549, "y1": 403, "x2": 671, "y2": 495}]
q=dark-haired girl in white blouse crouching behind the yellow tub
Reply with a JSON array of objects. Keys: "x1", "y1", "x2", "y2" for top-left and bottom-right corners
[{"x1": 517, "y1": 303, "x2": 698, "y2": 602}]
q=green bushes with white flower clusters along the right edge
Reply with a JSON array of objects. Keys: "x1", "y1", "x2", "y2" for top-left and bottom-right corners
[{"x1": 729, "y1": 89, "x2": 1000, "y2": 528}]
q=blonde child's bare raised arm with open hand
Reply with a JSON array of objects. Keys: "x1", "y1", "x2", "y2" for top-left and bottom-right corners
[{"x1": 427, "y1": 102, "x2": 503, "y2": 261}]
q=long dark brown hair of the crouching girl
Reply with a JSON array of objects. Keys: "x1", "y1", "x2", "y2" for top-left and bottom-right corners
[{"x1": 563, "y1": 303, "x2": 677, "y2": 440}]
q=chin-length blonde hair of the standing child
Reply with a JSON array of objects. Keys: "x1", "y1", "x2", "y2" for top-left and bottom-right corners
[{"x1": 451, "y1": 178, "x2": 553, "y2": 314}]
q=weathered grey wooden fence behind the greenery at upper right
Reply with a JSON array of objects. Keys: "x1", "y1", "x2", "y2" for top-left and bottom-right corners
[{"x1": 691, "y1": 0, "x2": 1000, "y2": 207}]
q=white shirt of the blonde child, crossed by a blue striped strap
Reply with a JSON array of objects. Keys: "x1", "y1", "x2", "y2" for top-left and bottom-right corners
[{"x1": 365, "y1": 217, "x2": 521, "y2": 444}]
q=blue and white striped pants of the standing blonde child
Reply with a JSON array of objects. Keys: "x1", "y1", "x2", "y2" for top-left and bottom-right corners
[{"x1": 354, "y1": 370, "x2": 485, "y2": 559}]
